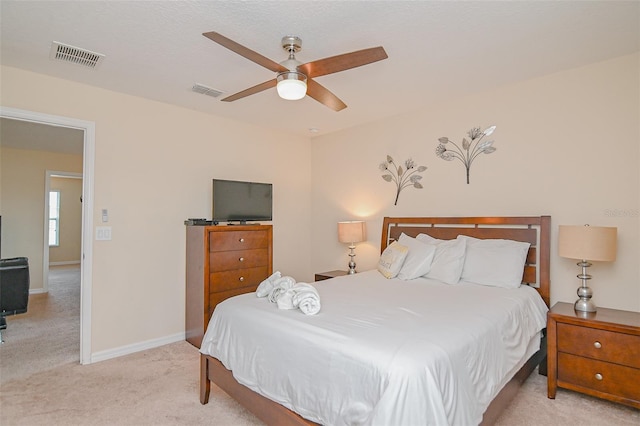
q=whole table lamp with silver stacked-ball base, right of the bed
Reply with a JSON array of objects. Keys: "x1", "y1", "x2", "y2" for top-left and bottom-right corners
[{"x1": 558, "y1": 225, "x2": 618, "y2": 312}]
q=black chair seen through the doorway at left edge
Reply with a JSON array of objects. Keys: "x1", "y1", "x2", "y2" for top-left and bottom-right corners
[{"x1": 0, "y1": 257, "x2": 29, "y2": 342}]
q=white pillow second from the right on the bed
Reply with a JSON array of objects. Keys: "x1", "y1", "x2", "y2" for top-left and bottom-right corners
[{"x1": 416, "y1": 234, "x2": 466, "y2": 284}]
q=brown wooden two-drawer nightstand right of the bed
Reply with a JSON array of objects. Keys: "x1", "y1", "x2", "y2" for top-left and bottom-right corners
[{"x1": 547, "y1": 303, "x2": 640, "y2": 408}]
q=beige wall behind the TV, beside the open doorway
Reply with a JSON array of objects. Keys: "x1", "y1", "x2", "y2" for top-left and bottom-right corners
[{"x1": 0, "y1": 67, "x2": 312, "y2": 353}]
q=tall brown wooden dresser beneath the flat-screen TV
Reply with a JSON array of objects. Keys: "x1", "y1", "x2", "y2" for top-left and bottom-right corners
[{"x1": 185, "y1": 225, "x2": 273, "y2": 347}]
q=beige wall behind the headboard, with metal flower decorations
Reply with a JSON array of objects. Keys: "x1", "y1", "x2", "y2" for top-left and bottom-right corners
[{"x1": 311, "y1": 54, "x2": 640, "y2": 311}]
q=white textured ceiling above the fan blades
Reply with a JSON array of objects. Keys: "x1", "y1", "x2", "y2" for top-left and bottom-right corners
[{"x1": 0, "y1": 0, "x2": 640, "y2": 136}]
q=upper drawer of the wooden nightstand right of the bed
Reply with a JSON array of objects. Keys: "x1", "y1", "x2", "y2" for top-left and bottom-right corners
[{"x1": 557, "y1": 323, "x2": 640, "y2": 368}]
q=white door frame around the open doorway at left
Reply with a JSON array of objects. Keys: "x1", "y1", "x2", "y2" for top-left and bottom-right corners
[{"x1": 0, "y1": 106, "x2": 96, "y2": 364}]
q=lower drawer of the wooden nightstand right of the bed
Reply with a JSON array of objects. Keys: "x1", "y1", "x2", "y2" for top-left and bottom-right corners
[{"x1": 558, "y1": 352, "x2": 640, "y2": 402}]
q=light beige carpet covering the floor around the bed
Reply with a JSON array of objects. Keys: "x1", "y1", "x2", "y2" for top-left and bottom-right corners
[{"x1": 0, "y1": 268, "x2": 640, "y2": 426}]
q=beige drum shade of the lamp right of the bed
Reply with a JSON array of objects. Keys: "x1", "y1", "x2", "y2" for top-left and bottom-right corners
[{"x1": 558, "y1": 225, "x2": 618, "y2": 262}]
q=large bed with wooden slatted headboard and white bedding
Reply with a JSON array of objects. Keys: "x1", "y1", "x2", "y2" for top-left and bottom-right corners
[{"x1": 200, "y1": 216, "x2": 550, "y2": 425}]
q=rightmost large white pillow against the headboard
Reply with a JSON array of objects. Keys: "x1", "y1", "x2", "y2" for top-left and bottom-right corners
[{"x1": 458, "y1": 235, "x2": 530, "y2": 288}]
